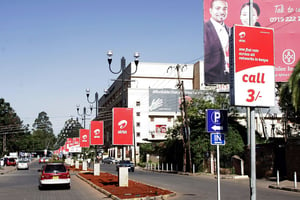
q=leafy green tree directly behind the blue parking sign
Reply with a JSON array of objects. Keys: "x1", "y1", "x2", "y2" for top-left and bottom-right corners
[{"x1": 164, "y1": 91, "x2": 246, "y2": 170}]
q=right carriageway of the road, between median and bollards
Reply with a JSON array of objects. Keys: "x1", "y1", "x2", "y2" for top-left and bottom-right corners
[{"x1": 101, "y1": 162, "x2": 300, "y2": 200}]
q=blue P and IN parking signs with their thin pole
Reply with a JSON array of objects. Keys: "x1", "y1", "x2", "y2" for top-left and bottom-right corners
[{"x1": 206, "y1": 109, "x2": 228, "y2": 200}]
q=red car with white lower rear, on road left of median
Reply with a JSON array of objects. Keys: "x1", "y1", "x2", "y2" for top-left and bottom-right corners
[{"x1": 38, "y1": 163, "x2": 71, "y2": 189}]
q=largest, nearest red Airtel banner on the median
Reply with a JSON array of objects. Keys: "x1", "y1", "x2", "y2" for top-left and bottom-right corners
[{"x1": 112, "y1": 108, "x2": 133, "y2": 145}]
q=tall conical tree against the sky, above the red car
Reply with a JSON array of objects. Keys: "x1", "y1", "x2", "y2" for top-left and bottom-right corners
[{"x1": 32, "y1": 111, "x2": 56, "y2": 150}]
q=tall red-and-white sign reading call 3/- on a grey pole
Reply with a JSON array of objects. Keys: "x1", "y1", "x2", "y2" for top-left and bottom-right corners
[{"x1": 230, "y1": 25, "x2": 275, "y2": 107}]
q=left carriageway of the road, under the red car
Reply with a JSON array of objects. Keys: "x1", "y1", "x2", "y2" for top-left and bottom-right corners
[{"x1": 0, "y1": 162, "x2": 109, "y2": 200}]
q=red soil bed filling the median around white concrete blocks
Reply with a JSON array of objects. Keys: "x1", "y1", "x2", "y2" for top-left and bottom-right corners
[{"x1": 79, "y1": 173, "x2": 173, "y2": 199}]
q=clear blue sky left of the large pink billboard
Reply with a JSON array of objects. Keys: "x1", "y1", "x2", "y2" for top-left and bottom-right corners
[{"x1": 0, "y1": 0, "x2": 203, "y2": 135}]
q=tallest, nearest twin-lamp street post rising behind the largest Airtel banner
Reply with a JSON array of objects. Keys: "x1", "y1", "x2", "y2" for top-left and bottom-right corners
[{"x1": 107, "y1": 50, "x2": 140, "y2": 161}]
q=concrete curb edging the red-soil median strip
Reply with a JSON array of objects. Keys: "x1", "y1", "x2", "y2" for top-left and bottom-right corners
[{"x1": 76, "y1": 174, "x2": 176, "y2": 200}]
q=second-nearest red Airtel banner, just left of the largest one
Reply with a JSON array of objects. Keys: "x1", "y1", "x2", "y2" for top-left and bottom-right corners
[{"x1": 90, "y1": 121, "x2": 104, "y2": 145}]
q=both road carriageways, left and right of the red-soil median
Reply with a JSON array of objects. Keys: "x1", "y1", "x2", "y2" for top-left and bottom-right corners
[{"x1": 0, "y1": 162, "x2": 300, "y2": 200}]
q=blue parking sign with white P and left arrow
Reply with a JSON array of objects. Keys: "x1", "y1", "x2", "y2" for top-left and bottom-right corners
[{"x1": 206, "y1": 109, "x2": 228, "y2": 133}]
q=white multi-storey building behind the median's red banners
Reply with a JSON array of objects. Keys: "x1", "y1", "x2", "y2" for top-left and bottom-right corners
[{"x1": 97, "y1": 61, "x2": 288, "y2": 162}]
